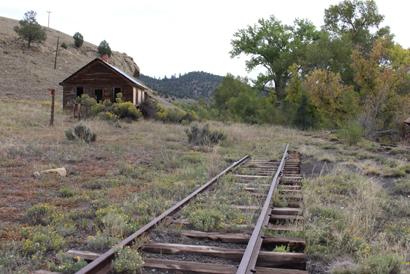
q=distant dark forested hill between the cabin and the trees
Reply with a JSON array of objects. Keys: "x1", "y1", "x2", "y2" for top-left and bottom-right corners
[{"x1": 137, "y1": 71, "x2": 222, "y2": 101}]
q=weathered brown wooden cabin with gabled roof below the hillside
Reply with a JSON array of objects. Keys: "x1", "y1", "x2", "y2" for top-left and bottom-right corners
[{"x1": 60, "y1": 56, "x2": 148, "y2": 108}]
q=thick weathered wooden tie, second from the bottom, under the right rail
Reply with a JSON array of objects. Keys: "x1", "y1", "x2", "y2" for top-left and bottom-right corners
[{"x1": 143, "y1": 243, "x2": 306, "y2": 270}]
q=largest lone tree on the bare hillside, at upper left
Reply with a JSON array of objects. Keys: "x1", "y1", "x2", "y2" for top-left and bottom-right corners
[{"x1": 14, "y1": 10, "x2": 47, "y2": 48}]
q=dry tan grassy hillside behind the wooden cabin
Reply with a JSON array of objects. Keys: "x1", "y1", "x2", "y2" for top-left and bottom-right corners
[{"x1": 0, "y1": 17, "x2": 179, "y2": 107}]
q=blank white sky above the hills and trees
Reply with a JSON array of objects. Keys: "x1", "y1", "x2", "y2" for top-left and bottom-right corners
[{"x1": 0, "y1": 0, "x2": 410, "y2": 78}]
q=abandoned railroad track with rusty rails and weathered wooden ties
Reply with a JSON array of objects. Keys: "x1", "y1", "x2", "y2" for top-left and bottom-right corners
[{"x1": 54, "y1": 145, "x2": 308, "y2": 274}]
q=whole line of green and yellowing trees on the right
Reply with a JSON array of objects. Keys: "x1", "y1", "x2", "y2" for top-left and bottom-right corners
[{"x1": 184, "y1": 0, "x2": 410, "y2": 134}]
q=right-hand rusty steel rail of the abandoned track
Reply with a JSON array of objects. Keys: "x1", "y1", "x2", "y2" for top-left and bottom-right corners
[{"x1": 236, "y1": 144, "x2": 289, "y2": 274}]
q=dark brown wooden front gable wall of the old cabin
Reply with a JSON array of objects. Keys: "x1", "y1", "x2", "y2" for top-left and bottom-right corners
[{"x1": 63, "y1": 62, "x2": 135, "y2": 108}]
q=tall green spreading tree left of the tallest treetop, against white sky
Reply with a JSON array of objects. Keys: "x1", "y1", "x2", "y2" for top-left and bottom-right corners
[{"x1": 230, "y1": 15, "x2": 319, "y2": 99}]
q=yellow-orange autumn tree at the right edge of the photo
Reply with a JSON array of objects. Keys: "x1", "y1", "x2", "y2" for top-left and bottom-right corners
[{"x1": 352, "y1": 38, "x2": 410, "y2": 130}]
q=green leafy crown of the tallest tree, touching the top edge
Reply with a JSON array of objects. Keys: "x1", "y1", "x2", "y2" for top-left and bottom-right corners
[{"x1": 323, "y1": 0, "x2": 390, "y2": 51}]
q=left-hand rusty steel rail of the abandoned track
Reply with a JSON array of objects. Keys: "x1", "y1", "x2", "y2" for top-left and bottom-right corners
[{"x1": 76, "y1": 155, "x2": 249, "y2": 274}]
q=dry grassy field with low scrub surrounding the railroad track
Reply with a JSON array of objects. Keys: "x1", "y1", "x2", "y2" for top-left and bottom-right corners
[{"x1": 0, "y1": 99, "x2": 410, "y2": 273}]
